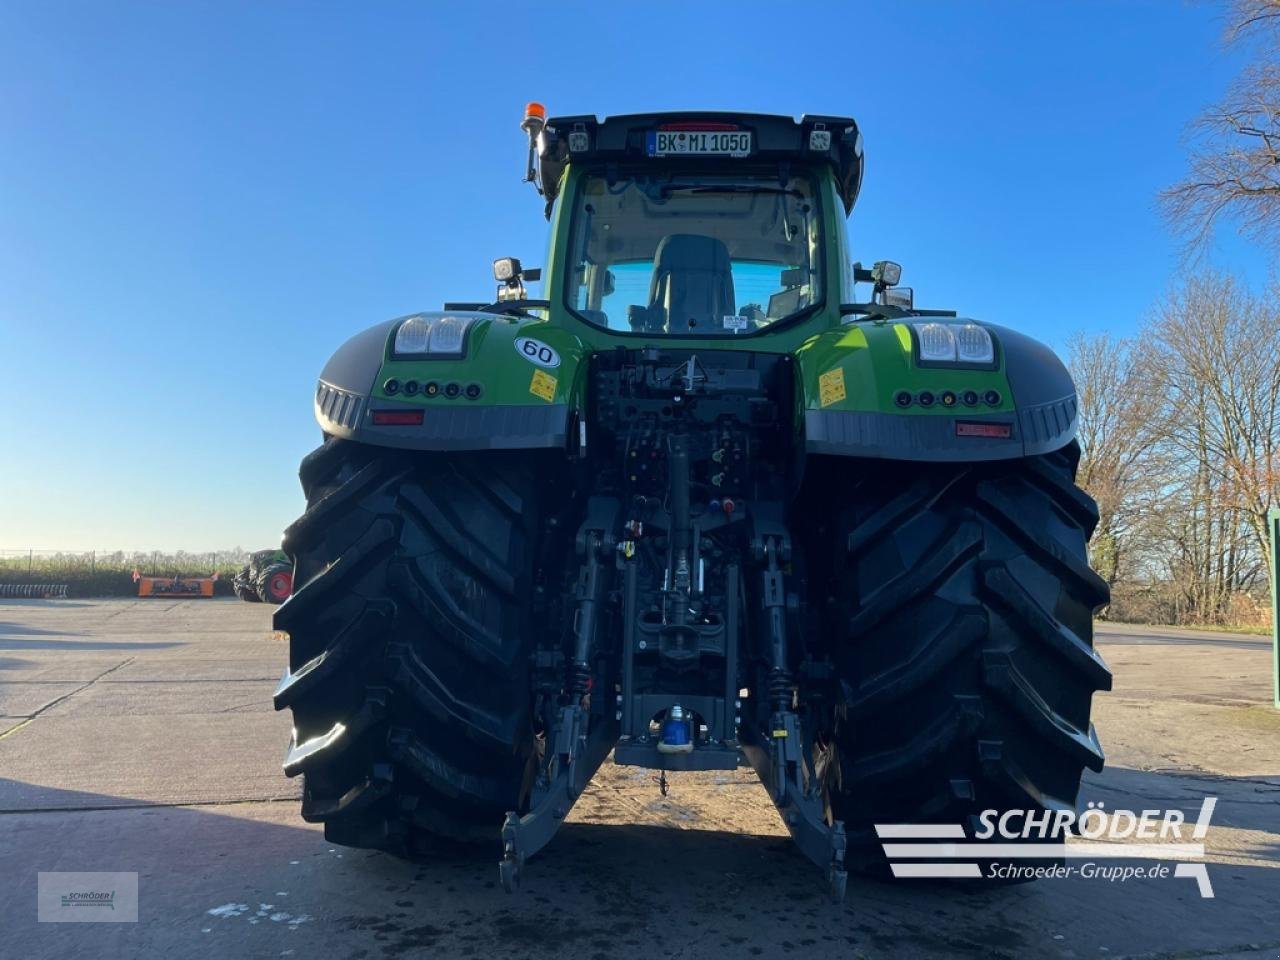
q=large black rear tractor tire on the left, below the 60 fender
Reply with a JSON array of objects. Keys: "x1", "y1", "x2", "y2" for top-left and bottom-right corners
[{"x1": 275, "y1": 439, "x2": 538, "y2": 856}]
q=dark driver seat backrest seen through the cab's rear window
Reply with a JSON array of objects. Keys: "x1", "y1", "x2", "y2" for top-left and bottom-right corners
[{"x1": 648, "y1": 233, "x2": 737, "y2": 333}]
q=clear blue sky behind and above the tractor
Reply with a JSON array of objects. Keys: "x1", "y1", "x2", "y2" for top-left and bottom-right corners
[{"x1": 0, "y1": 0, "x2": 1268, "y2": 550}]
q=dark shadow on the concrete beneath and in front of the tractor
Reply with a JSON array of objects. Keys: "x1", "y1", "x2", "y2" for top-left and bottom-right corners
[{"x1": 0, "y1": 771, "x2": 1280, "y2": 960}]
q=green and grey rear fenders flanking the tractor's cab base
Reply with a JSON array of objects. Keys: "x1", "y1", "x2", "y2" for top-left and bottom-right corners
[{"x1": 315, "y1": 311, "x2": 1076, "y2": 461}]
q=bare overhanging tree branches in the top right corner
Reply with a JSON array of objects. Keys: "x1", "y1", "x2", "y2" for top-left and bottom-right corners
[{"x1": 1161, "y1": 0, "x2": 1280, "y2": 248}]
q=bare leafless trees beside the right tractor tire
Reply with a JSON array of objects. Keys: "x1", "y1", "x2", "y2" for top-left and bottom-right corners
[{"x1": 1068, "y1": 274, "x2": 1280, "y2": 623}]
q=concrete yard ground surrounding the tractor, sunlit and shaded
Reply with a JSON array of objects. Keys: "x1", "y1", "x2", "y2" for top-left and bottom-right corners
[{"x1": 0, "y1": 599, "x2": 1280, "y2": 960}]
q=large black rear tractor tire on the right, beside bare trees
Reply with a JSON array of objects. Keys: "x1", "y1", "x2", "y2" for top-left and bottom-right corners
[{"x1": 820, "y1": 444, "x2": 1111, "y2": 869}]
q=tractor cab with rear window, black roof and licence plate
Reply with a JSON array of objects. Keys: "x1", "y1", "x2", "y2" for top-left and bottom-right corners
[{"x1": 522, "y1": 104, "x2": 863, "y2": 339}]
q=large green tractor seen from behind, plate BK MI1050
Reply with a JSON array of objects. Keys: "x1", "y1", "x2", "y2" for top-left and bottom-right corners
[{"x1": 275, "y1": 104, "x2": 1111, "y2": 896}]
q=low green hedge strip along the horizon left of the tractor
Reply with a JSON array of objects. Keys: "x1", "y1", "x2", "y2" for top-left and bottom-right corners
[{"x1": 0, "y1": 549, "x2": 248, "y2": 596}]
